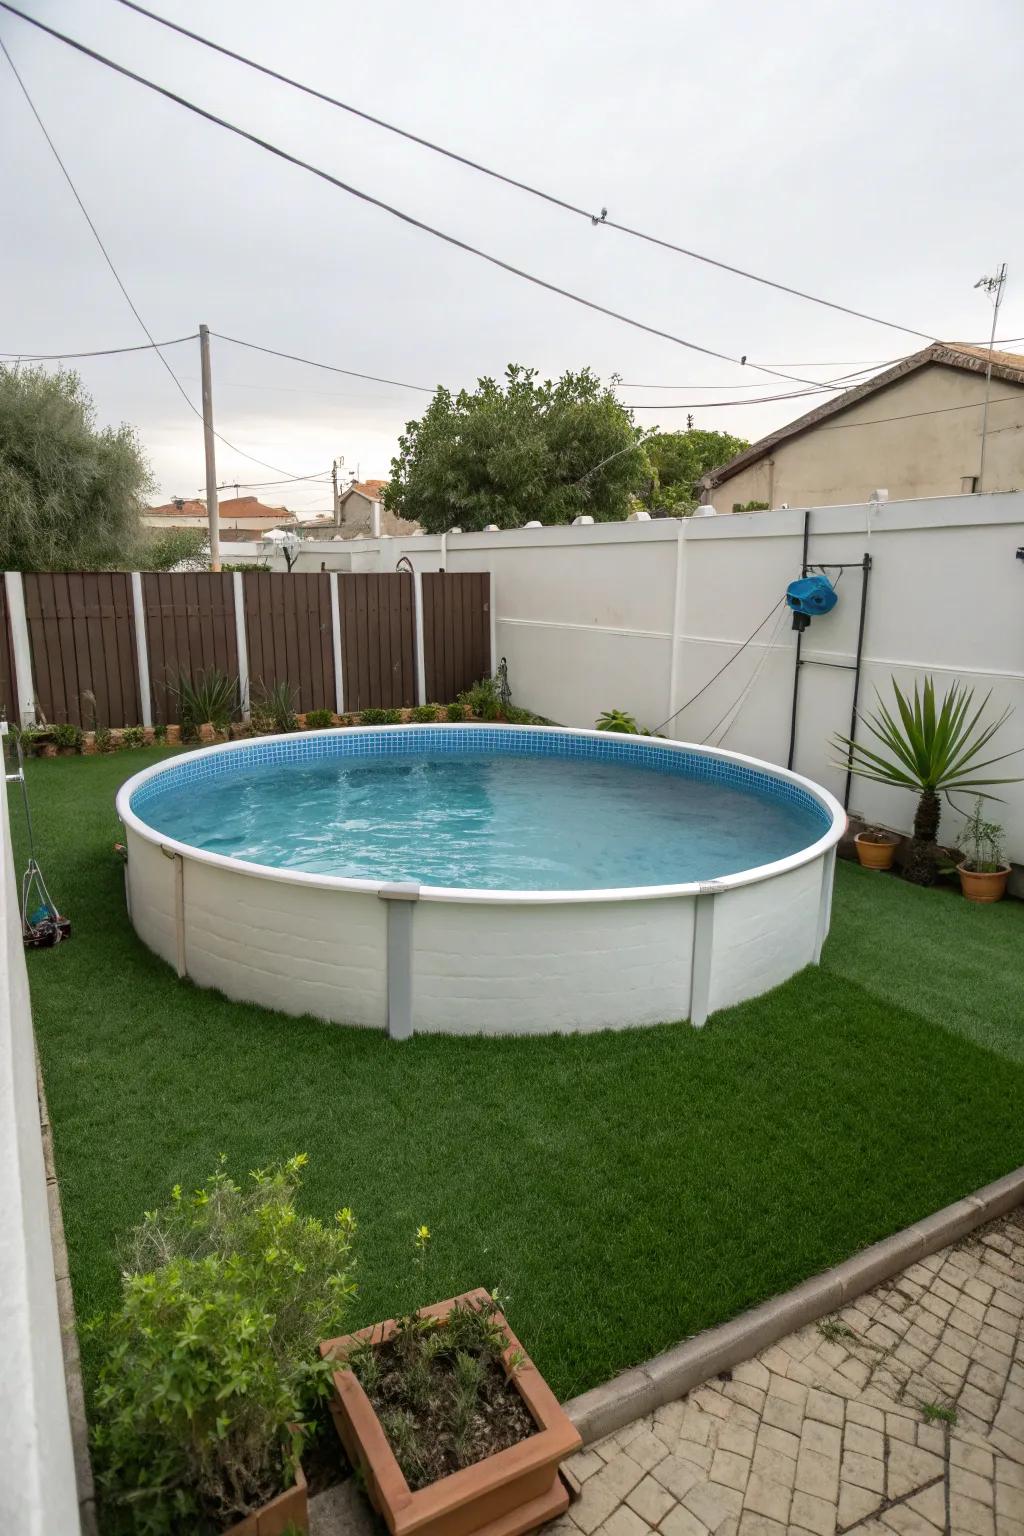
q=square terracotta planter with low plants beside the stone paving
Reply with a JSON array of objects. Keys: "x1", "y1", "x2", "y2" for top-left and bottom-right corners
[{"x1": 321, "y1": 1284, "x2": 582, "y2": 1536}]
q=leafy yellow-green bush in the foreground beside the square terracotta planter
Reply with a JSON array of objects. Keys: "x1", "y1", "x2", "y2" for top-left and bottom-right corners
[{"x1": 91, "y1": 1155, "x2": 355, "y2": 1536}]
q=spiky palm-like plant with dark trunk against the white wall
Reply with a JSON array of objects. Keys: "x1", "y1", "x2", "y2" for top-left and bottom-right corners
[{"x1": 835, "y1": 677, "x2": 1024, "y2": 885}]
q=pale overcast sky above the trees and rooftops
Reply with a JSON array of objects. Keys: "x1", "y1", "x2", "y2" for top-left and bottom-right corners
[{"x1": 0, "y1": 0, "x2": 1024, "y2": 515}]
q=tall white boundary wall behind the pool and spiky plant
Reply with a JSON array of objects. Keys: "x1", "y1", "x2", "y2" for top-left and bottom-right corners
[{"x1": 232, "y1": 492, "x2": 1024, "y2": 863}]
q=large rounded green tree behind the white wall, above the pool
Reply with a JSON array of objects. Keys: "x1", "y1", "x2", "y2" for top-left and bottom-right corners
[{"x1": 382, "y1": 364, "x2": 651, "y2": 533}]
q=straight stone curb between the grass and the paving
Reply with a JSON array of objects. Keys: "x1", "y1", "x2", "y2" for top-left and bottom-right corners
[{"x1": 563, "y1": 1167, "x2": 1024, "y2": 1445}]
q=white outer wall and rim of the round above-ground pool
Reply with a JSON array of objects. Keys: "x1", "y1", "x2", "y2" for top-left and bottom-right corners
[{"x1": 118, "y1": 725, "x2": 846, "y2": 1038}]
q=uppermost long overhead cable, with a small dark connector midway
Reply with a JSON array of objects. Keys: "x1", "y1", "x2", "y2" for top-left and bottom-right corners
[{"x1": 112, "y1": 0, "x2": 935, "y2": 341}]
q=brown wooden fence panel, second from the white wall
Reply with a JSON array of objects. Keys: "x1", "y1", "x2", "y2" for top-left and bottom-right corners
[{"x1": 338, "y1": 573, "x2": 416, "y2": 710}]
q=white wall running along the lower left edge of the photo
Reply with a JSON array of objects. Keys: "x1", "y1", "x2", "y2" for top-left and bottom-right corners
[{"x1": 0, "y1": 761, "x2": 80, "y2": 1536}]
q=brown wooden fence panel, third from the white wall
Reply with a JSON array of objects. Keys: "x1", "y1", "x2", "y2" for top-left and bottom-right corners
[{"x1": 243, "y1": 571, "x2": 335, "y2": 713}]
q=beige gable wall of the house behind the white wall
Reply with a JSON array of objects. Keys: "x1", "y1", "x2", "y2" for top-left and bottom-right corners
[{"x1": 711, "y1": 364, "x2": 1024, "y2": 511}]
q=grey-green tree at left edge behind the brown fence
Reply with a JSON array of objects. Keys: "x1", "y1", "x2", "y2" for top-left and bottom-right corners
[{"x1": 0, "y1": 366, "x2": 170, "y2": 571}]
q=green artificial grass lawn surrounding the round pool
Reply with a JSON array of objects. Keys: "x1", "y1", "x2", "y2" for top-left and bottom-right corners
[{"x1": 12, "y1": 750, "x2": 1024, "y2": 1398}]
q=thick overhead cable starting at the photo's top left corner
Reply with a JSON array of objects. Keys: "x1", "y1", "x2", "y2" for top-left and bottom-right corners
[{"x1": 0, "y1": 0, "x2": 847, "y2": 384}]
